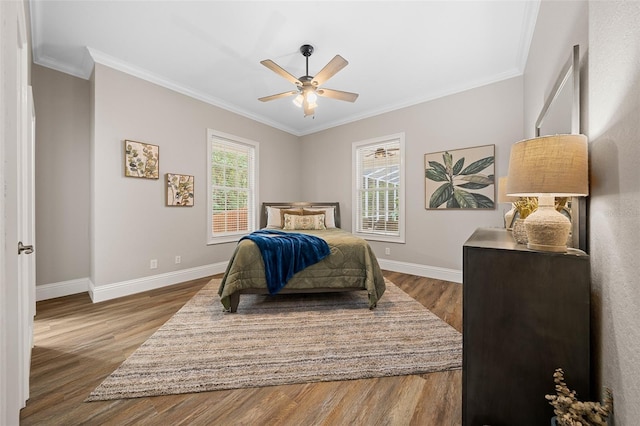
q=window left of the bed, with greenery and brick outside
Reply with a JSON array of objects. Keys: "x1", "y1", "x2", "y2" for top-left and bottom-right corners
[{"x1": 207, "y1": 129, "x2": 258, "y2": 244}]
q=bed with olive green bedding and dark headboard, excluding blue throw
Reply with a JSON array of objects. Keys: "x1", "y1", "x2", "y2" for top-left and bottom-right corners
[{"x1": 218, "y1": 202, "x2": 385, "y2": 312}]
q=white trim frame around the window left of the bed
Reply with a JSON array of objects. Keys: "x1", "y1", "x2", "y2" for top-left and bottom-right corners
[{"x1": 206, "y1": 129, "x2": 260, "y2": 245}]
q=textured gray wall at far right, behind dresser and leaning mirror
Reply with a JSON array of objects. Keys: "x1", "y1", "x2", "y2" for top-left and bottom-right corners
[{"x1": 524, "y1": 1, "x2": 640, "y2": 425}]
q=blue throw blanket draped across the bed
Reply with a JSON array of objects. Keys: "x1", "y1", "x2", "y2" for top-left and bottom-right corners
[{"x1": 240, "y1": 229, "x2": 330, "y2": 294}]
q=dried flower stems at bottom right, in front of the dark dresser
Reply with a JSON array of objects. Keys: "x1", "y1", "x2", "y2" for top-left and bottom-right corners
[{"x1": 545, "y1": 368, "x2": 613, "y2": 426}]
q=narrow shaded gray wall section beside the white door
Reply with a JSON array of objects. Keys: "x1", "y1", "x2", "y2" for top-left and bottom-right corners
[{"x1": 31, "y1": 65, "x2": 90, "y2": 284}]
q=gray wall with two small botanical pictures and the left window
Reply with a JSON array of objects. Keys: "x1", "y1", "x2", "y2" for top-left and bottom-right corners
[{"x1": 91, "y1": 64, "x2": 301, "y2": 287}]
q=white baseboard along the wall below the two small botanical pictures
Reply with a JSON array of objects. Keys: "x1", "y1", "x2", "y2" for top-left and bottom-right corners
[{"x1": 89, "y1": 261, "x2": 228, "y2": 303}]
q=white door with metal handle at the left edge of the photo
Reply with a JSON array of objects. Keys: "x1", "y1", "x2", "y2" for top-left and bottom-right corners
[{"x1": 0, "y1": 1, "x2": 35, "y2": 424}]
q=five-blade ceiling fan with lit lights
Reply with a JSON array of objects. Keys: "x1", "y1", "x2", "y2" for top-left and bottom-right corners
[{"x1": 258, "y1": 44, "x2": 358, "y2": 117}]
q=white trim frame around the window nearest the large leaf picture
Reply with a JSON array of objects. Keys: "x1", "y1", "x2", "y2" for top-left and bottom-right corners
[{"x1": 351, "y1": 132, "x2": 406, "y2": 244}]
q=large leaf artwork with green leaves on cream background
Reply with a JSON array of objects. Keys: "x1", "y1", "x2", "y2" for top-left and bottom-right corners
[{"x1": 424, "y1": 145, "x2": 495, "y2": 209}]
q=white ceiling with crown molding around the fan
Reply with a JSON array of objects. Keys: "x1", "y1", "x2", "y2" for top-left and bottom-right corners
[{"x1": 30, "y1": 0, "x2": 539, "y2": 136}]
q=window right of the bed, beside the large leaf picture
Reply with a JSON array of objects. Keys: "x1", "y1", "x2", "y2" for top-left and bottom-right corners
[{"x1": 353, "y1": 133, "x2": 404, "y2": 243}]
